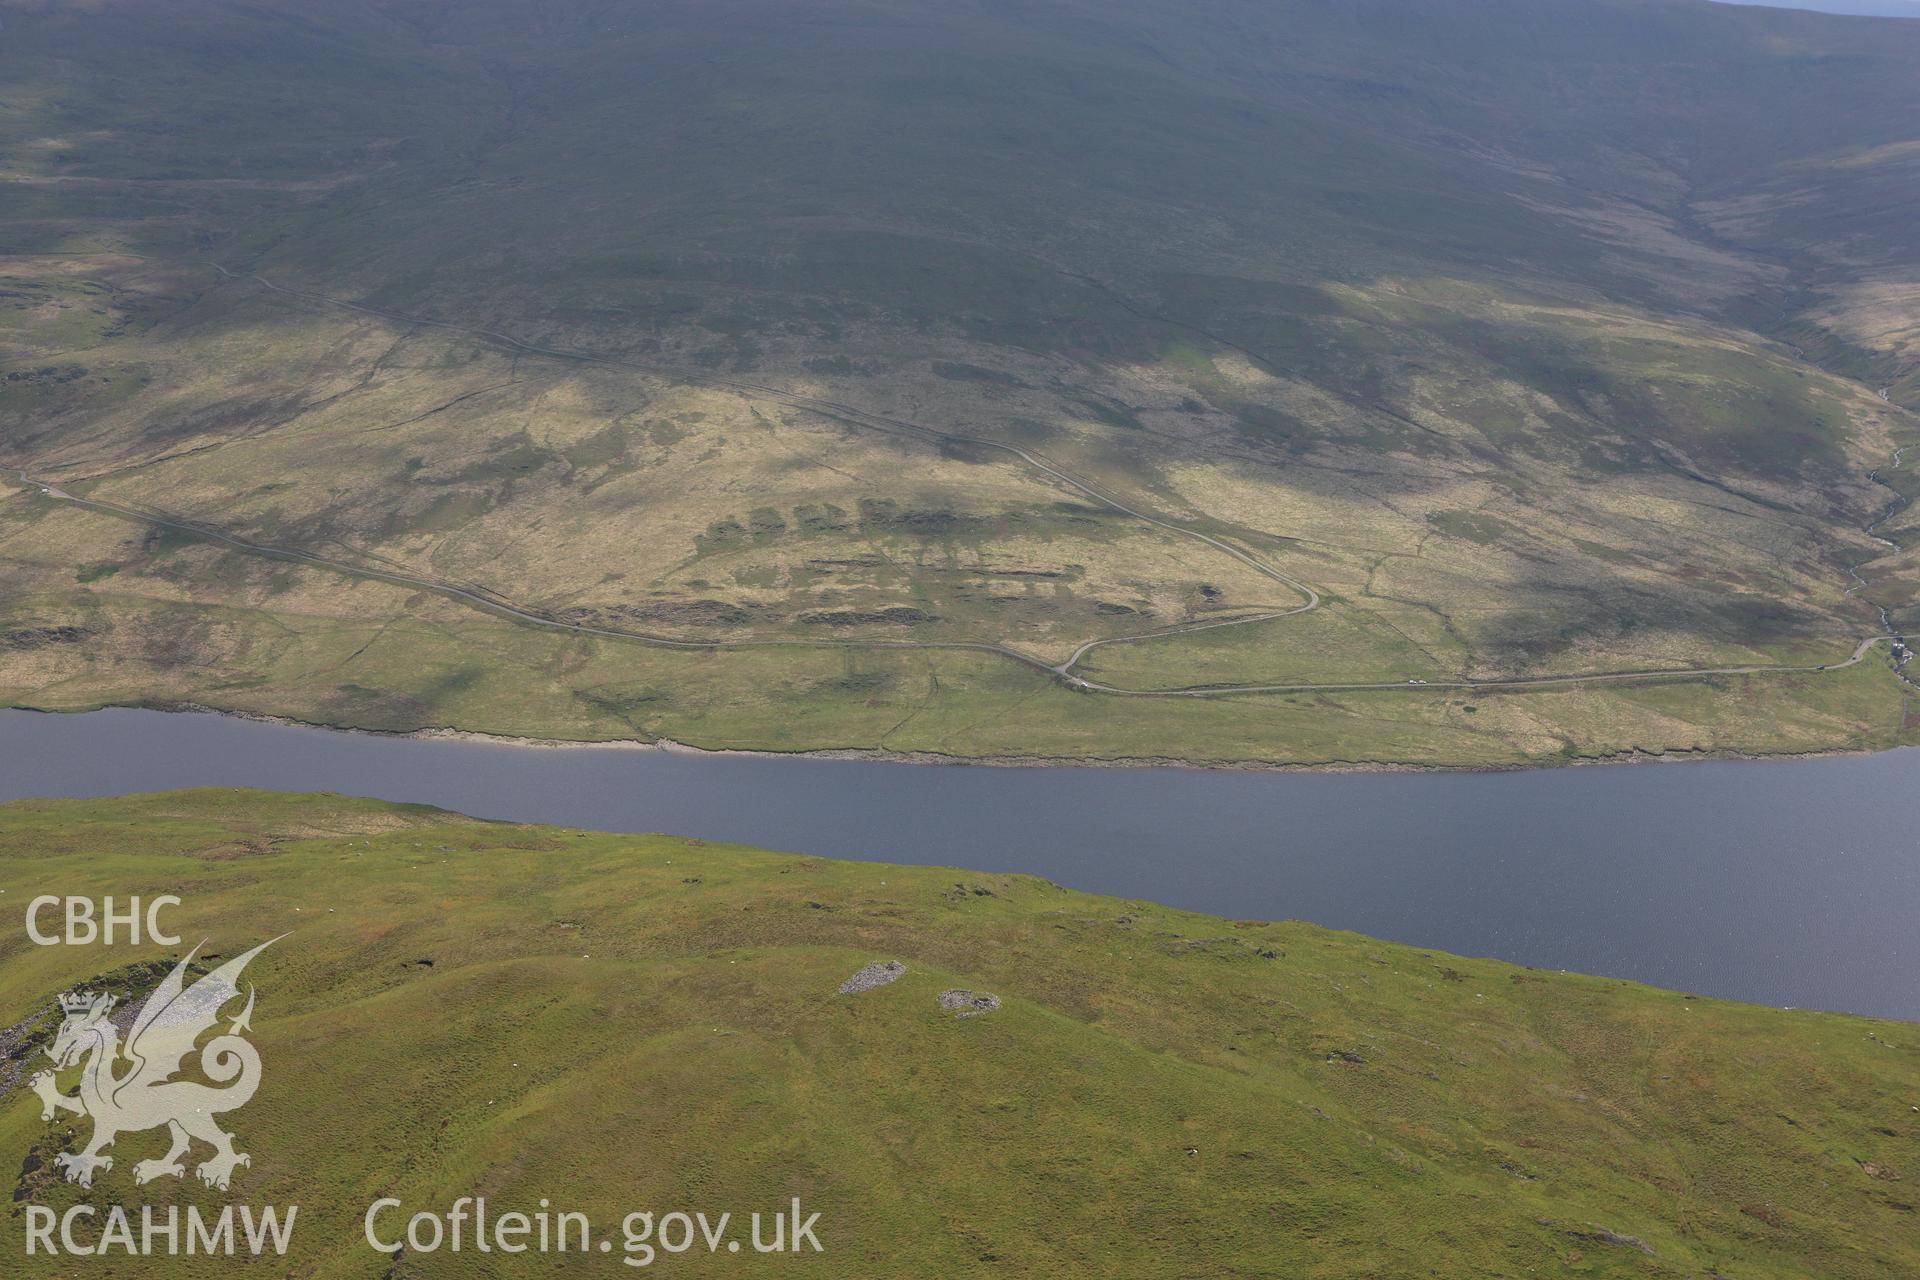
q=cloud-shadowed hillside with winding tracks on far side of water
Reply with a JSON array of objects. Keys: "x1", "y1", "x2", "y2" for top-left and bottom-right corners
[{"x1": 0, "y1": 0, "x2": 1920, "y2": 762}]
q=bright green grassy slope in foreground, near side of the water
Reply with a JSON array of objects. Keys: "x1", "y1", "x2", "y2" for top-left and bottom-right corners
[{"x1": 0, "y1": 791, "x2": 1920, "y2": 1280}]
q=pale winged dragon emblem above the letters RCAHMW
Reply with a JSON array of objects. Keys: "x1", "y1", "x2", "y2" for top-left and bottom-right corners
[{"x1": 31, "y1": 938, "x2": 278, "y2": 1192}]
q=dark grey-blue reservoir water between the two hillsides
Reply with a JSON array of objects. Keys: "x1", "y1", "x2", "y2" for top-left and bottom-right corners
[{"x1": 0, "y1": 710, "x2": 1920, "y2": 1019}]
